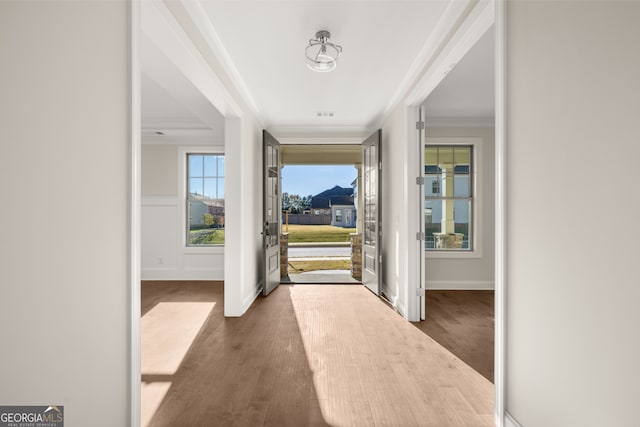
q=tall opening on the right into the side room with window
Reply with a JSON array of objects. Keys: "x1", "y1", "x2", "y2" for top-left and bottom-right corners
[{"x1": 416, "y1": 27, "x2": 496, "y2": 382}]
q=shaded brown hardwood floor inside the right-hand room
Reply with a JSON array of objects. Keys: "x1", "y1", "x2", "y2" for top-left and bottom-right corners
[{"x1": 414, "y1": 290, "x2": 495, "y2": 382}]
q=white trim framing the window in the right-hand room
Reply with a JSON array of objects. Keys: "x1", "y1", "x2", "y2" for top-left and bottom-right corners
[{"x1": 422, "y1": 137, "x2": 484, "y2": 259}]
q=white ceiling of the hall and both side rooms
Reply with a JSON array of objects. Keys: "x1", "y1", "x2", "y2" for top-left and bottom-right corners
[{"x1": 141, "y1": 0, "x2": 494, "y2": 143}]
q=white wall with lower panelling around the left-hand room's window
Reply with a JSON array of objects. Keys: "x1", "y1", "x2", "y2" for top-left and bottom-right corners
[{"x1": 140, "y1": 144, "x2": 224, "y2": 280}]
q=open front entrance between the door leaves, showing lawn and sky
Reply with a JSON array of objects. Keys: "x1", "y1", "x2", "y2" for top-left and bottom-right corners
[{"x1": 281, "y1": 144, "x2": 362, "y2": 284}]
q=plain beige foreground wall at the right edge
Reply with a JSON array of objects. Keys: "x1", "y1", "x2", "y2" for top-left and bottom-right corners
[{"x1": 506, "y1": 1, "x2": 640, "y2": 427}]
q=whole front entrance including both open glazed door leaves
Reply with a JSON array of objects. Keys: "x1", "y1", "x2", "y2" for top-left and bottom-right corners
[{"x1": 263, "y1": 135, "x2": 382, "y2": 295}]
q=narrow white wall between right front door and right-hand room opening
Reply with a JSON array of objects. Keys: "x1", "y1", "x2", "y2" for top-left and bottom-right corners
[{"x1": 382, "y1": 105, "x2": 408, "y2": 316}]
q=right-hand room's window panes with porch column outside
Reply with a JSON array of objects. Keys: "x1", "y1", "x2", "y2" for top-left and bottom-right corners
[{"x1": 424, "y1": 145, "x2": 475, "y2": 251}]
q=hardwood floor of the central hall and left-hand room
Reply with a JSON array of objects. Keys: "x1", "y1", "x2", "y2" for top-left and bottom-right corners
[{"x1": 142, "y1": 282, "x2": 493, "y2": 427}]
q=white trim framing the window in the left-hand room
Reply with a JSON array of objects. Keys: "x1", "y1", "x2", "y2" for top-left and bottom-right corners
[{"x1": 178, "y1": 145, "x2": 227, "y2": 254}]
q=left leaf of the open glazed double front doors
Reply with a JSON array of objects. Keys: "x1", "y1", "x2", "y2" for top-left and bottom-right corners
[{"x1": 262, "y1": 130, "x2": 282, "y2": 295}]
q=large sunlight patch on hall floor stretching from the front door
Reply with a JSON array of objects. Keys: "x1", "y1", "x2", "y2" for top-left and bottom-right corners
[{"x1": 288, "y1": 285, "x2": 493, "y2": 427}]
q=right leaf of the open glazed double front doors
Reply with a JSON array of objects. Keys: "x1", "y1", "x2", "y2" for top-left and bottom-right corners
[{"x1": 362, "y1": 129, "x2": 382, "y2": 296}]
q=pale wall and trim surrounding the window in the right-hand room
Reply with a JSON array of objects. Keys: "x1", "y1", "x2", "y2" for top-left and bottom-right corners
[{"x1": 425, "y1": 125, "x2": 495, "y2": 289}]
